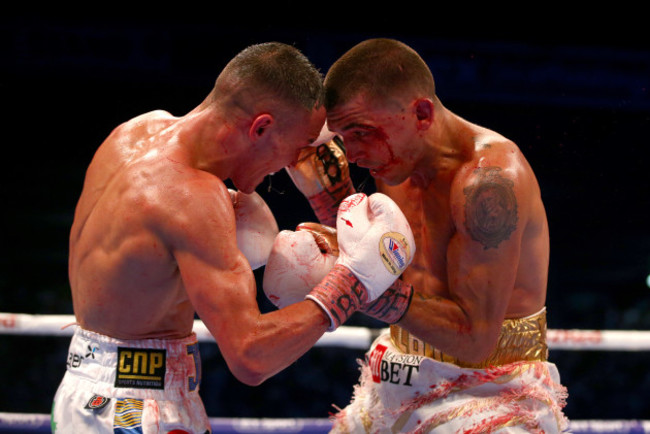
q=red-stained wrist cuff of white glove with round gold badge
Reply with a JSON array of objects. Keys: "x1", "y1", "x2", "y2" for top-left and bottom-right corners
[{"x1": 305, "y1": 264, "x2": 368, "y2": 331}]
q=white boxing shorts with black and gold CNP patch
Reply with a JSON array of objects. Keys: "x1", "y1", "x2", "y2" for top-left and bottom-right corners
[{"x1": 51, "y1": 327, "x2": 210, "y2": 434}]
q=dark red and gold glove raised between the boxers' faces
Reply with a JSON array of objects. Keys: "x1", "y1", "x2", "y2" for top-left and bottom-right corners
[{"x1": 286, "y1": 124, "x2": 355, "y2": 226}]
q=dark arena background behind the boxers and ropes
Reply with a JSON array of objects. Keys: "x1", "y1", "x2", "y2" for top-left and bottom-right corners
[{"x1": 0, "y1": 8, "x2": 650, "y2": 419}]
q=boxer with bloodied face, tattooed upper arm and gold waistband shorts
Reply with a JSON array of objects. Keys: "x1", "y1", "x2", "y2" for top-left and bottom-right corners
[{"x1": 284, "y1": 39, "x2": 565, "y2": 432}]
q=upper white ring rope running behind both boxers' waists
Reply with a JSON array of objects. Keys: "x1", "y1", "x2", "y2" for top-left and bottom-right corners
[{"x1": 0, "y1": 313, "x2": 650, "y2": 351}]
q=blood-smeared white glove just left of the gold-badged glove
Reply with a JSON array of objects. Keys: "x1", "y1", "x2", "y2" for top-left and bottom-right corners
[{"x1": 262, "y1": 223, "x2": 338, "y2": 308}]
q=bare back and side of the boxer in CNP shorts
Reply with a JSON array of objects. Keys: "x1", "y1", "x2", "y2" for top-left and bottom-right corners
[{"x1": 69, "y1": 112, "x2": 202, "y2": 339}]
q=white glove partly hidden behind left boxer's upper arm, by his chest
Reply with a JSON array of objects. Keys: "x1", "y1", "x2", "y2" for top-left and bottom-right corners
[{"x1": 228, "y1": 189, "x2": 279, "y2": 270}]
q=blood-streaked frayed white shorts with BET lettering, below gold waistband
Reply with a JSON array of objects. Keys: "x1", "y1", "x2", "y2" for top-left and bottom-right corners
[{"x1": 332, "y1": 333, "x2": 568, "y2": 434}]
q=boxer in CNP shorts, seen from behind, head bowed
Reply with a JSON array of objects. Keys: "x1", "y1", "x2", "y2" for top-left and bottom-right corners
[{"x1": 58, "y1": 43, "x2": 411, "y2": 433}]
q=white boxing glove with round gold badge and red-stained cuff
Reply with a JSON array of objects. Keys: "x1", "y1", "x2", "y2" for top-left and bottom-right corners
[{"x1": 306, "y1": 193, "x2": 415, "y2": 331}]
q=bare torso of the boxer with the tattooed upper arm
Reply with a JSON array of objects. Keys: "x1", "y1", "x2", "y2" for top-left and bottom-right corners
[{"x1": 377, "y1": 130, "x2": 549, "y2": 318}]
